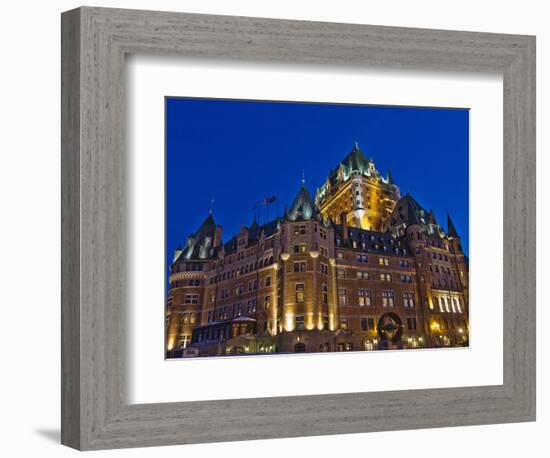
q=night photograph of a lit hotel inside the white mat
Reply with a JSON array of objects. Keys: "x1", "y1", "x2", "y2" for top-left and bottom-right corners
[{"x1": 165, "y1": 98, "x2": 469, "y2": 358}]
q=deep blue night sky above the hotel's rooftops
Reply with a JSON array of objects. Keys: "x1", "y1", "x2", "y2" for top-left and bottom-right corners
[{"x1": 166, "y1": 98, "x2": 469, "y2": 274}]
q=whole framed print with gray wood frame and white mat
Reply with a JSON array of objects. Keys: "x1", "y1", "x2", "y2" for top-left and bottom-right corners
[{"x1": 62, "y1": 7, "x2": 535, "y2": 450}]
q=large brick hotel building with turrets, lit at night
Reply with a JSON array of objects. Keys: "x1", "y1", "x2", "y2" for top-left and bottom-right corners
[{"x1": 166, "y1": 144, "x2": 469, "y2": 358}]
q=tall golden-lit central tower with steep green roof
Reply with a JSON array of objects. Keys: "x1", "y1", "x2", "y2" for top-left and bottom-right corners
[{"x1": 315, "y1": 143, "x2": 401, "y2": 231}]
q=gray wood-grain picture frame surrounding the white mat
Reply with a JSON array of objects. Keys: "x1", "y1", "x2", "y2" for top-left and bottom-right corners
[{"x1": 61, "y1": 7, "x2": 536, "y2": 450}]
